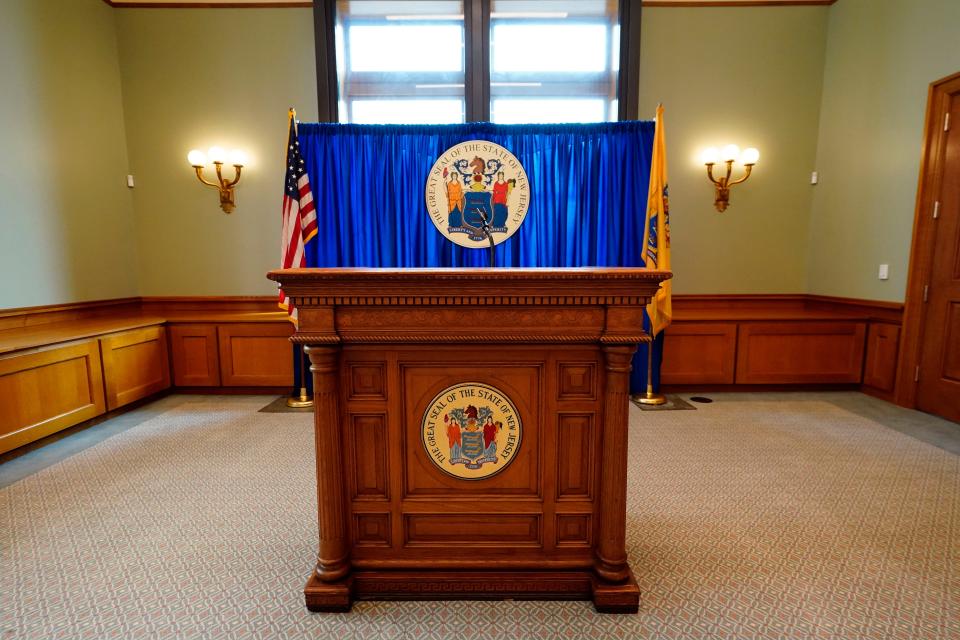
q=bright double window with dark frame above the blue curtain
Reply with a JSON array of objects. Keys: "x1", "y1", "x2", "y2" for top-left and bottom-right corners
[{"x1": 322, "y1": 0, "x2": 640, "y2": 124}]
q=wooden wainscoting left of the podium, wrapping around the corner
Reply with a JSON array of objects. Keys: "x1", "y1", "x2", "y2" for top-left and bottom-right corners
[{"x1": 0, "y1": 296, "x2": 293, "y2": 453}]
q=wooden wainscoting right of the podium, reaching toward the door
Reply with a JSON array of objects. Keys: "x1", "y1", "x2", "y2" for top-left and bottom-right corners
[{"x1": 661, "y1": 294, "x2": 903, "y2": 400}]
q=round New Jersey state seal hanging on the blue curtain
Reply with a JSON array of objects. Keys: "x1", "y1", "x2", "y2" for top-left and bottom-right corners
[{"x1": 426, "y1": 140, "x2": 530, "y2": 249}]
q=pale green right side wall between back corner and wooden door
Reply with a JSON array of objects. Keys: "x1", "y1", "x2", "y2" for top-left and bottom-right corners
[{"x1": 809, "y1": 0, "x2": 960, "y2": 301}]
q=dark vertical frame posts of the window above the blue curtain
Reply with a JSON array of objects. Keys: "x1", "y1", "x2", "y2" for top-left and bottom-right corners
[{"x1": 313, "y1": 0, "x2": 642, "y2": 122}]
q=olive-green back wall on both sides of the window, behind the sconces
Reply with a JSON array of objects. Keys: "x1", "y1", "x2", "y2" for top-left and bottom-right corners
[{"x1": 117, "y1": 7, "x2": 827, "y2": 295}]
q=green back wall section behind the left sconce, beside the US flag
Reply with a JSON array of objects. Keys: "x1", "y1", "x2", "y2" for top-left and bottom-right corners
[{"x1": 115, "y1": 9, "x2": 317, "y2": 296}]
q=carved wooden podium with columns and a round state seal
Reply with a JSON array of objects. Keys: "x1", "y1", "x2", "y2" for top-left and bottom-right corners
[{"x1": 268, "y1": 268, "x2": 670, "y2": 613}]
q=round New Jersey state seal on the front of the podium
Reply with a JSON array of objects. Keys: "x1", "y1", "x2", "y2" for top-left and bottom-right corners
[{"x1": 420, "y1": 382, "x2": 523, "y2": 480}]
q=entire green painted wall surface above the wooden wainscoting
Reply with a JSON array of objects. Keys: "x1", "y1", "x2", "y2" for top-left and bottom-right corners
[{"x1": 0, "y1": 0, "x2": 960, "y2": 307}]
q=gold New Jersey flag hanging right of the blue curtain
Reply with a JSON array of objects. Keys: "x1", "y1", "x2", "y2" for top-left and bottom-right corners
[{"x1": 643, "y1": 105, "x2": 673, "y2": 336}]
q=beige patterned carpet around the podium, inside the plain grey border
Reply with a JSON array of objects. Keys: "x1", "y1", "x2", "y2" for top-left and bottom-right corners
[{"x1": 0, "y1": 395, "x2": 960, "y2": 640}]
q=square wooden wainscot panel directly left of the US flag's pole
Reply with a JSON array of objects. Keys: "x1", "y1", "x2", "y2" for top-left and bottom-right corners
[{"x1": 217, "y1": 323, "x2": 293, "y2": 387}]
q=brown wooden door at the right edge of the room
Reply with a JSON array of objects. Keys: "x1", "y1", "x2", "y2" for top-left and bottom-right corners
[{"x1": 917, "y1": 78, "x2": 960, "y2": 422}]
